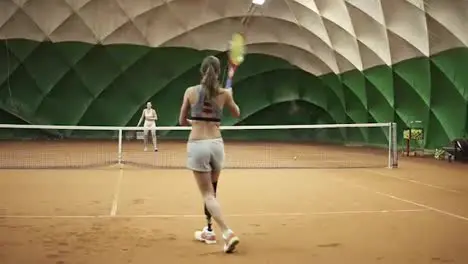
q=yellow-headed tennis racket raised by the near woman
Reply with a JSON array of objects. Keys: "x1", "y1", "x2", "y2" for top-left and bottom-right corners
[{"x1": 226, "y1": 33, "x2": 246, "y2": 89}]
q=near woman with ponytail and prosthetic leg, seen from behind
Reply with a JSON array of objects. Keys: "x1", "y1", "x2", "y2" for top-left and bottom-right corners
[{"x1": 179, "y1": 56, "x2": 240, "y2": 253}]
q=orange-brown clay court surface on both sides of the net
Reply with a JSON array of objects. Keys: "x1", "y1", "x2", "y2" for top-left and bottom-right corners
[{"x1": 0, "y1": 142, "x2": 468, "y2": 264}]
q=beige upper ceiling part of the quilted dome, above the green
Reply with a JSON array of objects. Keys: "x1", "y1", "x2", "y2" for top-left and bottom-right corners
[{"x1": 0, "y1": 0, "x2": 468, "y2": 75}]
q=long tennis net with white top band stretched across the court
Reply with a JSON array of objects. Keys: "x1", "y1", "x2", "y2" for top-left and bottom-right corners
[{"x1": 0, "y1": 123, "x2": 398, "y2": 169}]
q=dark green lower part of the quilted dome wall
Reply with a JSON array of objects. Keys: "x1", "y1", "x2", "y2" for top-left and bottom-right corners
[{"x1": 0, "y1": 40, "x2": 468, "y2": 148}]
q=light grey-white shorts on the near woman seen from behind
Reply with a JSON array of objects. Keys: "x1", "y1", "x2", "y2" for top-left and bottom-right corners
[{"x1": 187, "y1": 138, "x2": 224, "y2": 172}]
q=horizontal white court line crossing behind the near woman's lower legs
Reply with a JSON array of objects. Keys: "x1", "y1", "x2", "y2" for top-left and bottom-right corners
[{"x1": 0, "y1": 209, "x2": 429, "y2": 219}]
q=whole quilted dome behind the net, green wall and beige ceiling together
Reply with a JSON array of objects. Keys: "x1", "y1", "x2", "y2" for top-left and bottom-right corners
[{"x1": 0, "y1": 0, "x2": 468, "y2": 147}]
